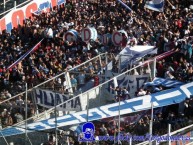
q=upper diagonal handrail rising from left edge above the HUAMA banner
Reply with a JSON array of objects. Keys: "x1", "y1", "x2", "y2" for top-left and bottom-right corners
[{"x1": 0, "y1": 53, "x2": 107, "y2": 105}]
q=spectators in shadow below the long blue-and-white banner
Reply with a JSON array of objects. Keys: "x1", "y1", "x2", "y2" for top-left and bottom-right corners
[{"x1": 42, "y1": 98, "x2": 193, "y2": 145}]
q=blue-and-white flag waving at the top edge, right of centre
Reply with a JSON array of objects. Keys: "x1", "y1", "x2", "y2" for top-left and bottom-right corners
[{"x1": 145, "y1": 0, "x2": 164, "y2": 12}]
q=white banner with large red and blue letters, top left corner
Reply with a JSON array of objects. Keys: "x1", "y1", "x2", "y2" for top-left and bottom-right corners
[{"x1": 0, "y1": 0, "x2": 66, "y2": 32}]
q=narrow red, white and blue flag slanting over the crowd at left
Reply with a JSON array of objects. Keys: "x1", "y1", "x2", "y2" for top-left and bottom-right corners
[{"x1": 7, "y1": 39, "x2": 43, "y2": 70}]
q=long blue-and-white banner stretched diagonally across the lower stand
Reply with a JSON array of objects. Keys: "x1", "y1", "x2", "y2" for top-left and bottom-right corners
[{"x1": 0, "y1": 82, "x2": 193, "y2": 137}]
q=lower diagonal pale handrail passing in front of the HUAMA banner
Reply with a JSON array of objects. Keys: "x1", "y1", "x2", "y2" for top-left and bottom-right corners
[{"x1": 14, "y1": 51, "x2": 158, "y2": 126}]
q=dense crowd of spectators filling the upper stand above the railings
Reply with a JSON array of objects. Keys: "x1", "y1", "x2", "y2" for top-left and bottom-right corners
[{"x1": 0, "y1": 0, "x2": 193, "y2": 144}]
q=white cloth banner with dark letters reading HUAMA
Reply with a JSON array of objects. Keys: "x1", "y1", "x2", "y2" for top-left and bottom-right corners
[{"x1": 34, "y1": 89, "x2": 81, "y2": 111}]
